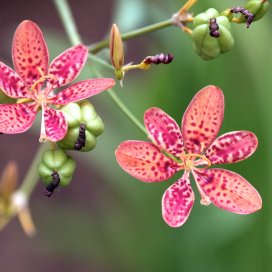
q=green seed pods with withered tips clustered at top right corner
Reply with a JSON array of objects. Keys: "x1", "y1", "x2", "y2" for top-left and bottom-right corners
[{"x1": 192, "y1": 0, "x2": 269, "y2": 60}]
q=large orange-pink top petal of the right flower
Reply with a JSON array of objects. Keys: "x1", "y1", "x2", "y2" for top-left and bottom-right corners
[{"x1": 181, "y1": 85, "x2": 224, "y2": 154}]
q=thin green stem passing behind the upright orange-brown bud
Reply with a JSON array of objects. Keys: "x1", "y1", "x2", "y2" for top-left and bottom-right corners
[{"x1": 89, "y1": 19, "x2": 173, "y2": 54}]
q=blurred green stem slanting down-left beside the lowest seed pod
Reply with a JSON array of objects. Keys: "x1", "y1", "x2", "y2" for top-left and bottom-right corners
[{"x1": 19, "y1": 143, "x2": 46, "y2": 196}]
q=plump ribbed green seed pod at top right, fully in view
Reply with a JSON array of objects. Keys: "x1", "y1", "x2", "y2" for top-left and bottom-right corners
[{"x1": 192, "y1": 8, "x2": 234, "y2": 60}]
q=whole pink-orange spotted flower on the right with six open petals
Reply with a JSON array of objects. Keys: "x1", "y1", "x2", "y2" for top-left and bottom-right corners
[{"x1": 116, "y1": 86, "x2": 262, "y2": 227}]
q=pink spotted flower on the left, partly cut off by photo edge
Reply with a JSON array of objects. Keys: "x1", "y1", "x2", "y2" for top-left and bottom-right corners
[{"x1": 0, "y1": 20, "x2": 114, "y2": 142}]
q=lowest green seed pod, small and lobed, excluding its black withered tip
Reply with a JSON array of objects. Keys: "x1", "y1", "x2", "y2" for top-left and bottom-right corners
[{"x1": 38, "y1": 149, "x2": 76, "y2": 186}]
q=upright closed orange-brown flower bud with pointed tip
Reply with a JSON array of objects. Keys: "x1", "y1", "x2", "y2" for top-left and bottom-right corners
[{"x1": 110, "y1": 24, "x2": 124, "y2": 80}]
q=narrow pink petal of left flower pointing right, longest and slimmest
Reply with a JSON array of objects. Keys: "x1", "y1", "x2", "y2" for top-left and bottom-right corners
[{"x1": 49, "y1": 78, "x2": 115, "y2": 105}]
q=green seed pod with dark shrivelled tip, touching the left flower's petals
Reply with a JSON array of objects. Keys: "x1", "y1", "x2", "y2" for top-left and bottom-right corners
[{"x1": 57, "y1": 100, "x2": 104, "y2": 152}]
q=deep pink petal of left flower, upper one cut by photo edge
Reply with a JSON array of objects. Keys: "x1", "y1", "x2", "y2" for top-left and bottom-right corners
[{"x1": 0, "y1": 62, "x2": 33, "y2": 98}]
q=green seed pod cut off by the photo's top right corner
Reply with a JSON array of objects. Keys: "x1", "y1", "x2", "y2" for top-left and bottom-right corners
[{"x1": 240, "y1": 0, "x2": 269, "y2": 23}]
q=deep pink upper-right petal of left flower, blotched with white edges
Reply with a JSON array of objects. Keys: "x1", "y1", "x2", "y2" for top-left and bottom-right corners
[{"x1": 48, "y1": 44, "x2": 88, "y2": 88}]
